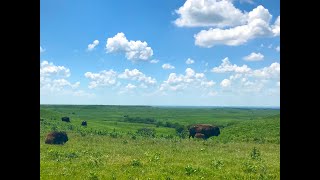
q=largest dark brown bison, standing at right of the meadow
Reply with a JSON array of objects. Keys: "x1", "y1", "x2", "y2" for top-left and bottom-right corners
[{"x1": 189, "y1": 124, "x2": 220, "y2": 139}]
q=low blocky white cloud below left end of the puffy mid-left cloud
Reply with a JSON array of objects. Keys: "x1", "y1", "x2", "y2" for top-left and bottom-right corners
[{"x1": 84, "y1": 69, "x2": 117, "y2": 89}]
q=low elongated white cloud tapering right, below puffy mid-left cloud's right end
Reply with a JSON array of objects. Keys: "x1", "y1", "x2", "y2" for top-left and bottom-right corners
[{"x1": 118, "y1": 69, "x2": 157, "y2": 85}]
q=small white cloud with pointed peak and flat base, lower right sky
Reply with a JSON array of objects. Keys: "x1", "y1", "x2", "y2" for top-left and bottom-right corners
[{"x1": 211, "y1": 57, "x2": 251, "y2": 73}]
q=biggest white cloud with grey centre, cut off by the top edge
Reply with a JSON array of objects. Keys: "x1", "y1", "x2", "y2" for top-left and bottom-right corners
[{"x1": 174, "y1": 0, "x2": 246, "y2": 27}]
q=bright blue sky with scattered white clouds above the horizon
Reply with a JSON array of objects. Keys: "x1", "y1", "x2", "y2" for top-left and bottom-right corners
[{"x1": 40, "y1": 0, "x2": 280, "y2": 106}]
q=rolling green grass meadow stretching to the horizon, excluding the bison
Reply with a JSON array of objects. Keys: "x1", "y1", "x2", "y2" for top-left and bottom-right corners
[{"x1": 40, "y1": 105, "x2": 280, "y2": 180}]
